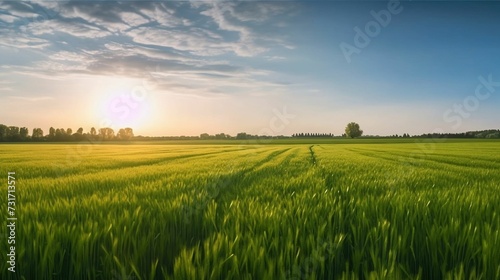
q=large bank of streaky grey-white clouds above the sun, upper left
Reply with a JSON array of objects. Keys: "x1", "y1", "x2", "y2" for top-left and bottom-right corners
[{"x1": 0, "y1": 1, "x2": 296, "y2": 98}]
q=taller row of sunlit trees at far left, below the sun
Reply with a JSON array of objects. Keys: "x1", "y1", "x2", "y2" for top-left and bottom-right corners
[{"x1": 0, "y1": 124, "x2": 134, "y2": 142}]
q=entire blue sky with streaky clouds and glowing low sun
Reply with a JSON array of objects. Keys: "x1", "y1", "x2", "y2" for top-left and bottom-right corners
[{"x1": 0, "y1": 1, "x2": 500, "y2": 136}]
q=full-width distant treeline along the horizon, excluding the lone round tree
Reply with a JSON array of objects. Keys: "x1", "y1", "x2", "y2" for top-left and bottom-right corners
[{"x1": 0, "y1": 124, "x2": 500, "y2": 142}]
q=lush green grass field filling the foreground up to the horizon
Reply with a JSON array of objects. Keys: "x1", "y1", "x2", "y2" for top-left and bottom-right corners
[{"x1": 0, "y1": 139, "x2": 500, "y2": 280}]
